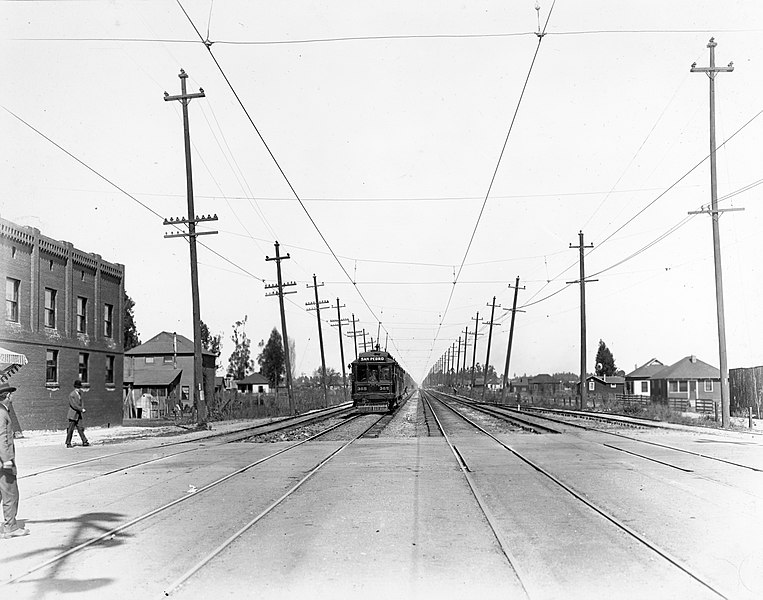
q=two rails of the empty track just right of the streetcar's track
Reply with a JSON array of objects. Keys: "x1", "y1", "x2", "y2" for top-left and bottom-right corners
[{"x1": 425, "y1": 393, "x2": 730, "y2": 598}]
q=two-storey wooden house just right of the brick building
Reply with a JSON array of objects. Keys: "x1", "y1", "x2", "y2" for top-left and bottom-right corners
[{"x1": 124, "y1": 331, "x2": 217, "y2": 419}]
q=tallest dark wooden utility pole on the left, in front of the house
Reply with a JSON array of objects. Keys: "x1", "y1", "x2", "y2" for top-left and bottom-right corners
[{"x1": 164, "y1": 69, "x2": 217, "y2": 426}]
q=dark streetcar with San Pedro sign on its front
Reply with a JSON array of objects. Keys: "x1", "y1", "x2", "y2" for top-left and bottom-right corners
[{"x1": 350, "y1": 345, "x2": 411, "y2": 412}]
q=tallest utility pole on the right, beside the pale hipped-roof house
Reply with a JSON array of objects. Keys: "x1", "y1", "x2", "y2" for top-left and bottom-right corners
[{"x1": 690, "y1": 38, "x2": 744, "y2": 428}]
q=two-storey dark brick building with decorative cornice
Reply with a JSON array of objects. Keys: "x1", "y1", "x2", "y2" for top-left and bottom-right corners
[{"x1": 0, "y1": 219, "x2": 124, "y2": 429}]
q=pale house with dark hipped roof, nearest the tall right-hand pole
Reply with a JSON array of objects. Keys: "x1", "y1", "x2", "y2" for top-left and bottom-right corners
[{"x1": 651, "y1": 355, "x2": 721, "y2": 412}]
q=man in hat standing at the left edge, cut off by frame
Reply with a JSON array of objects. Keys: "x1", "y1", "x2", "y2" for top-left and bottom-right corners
[{"x1": 0, "y1": 384, "x2": 29, "y2": 538}]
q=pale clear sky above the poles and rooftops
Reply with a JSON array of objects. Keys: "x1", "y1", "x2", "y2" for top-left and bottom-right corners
[{"x1": 0, "y1": 0, "x2": 763, "y2": 381}]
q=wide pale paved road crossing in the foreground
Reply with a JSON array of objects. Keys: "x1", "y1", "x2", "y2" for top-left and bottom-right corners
[{"x1": 0, "y1": 397, "x2": 763, "y2": 600}]
